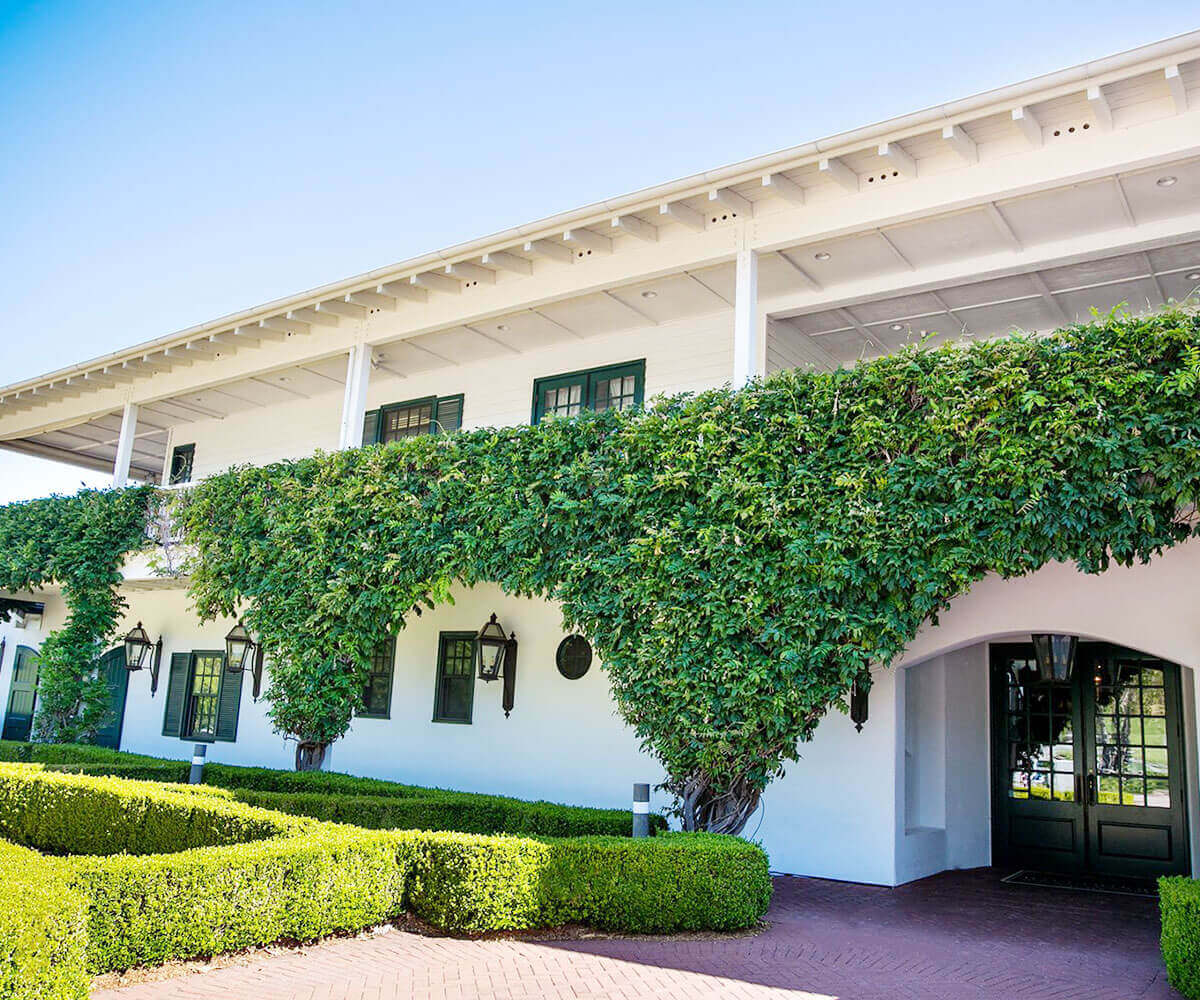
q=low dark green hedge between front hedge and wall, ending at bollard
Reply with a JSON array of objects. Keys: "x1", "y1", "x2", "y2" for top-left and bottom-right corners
[{"x1": 234, "y1": 789, "x2": 666, "y2": 837}]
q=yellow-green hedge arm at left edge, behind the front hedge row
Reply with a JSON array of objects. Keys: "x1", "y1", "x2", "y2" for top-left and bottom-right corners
[{"x1": 0, "y1": 764, "x2": 295, "y2": 855}]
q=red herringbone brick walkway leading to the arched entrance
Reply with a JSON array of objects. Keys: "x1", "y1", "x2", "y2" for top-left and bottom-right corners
[{"x1": 92, "y1": 869, "x2": 1177, "y2": 1000}]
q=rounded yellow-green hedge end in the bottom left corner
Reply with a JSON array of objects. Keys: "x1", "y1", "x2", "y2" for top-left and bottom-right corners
[{"x1": 0, "y1": 840, "x2": 89, "y2": 1000}]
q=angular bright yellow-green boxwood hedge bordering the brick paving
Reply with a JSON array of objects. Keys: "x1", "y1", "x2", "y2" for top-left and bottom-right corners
[{"x1": 0, "y1": 764, "x2": 770, "y2": 979}]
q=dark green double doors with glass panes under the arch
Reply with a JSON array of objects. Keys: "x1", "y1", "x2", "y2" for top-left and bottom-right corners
[{"x1": 991, "y1": 642, "x2": 1190, "y2": 878}]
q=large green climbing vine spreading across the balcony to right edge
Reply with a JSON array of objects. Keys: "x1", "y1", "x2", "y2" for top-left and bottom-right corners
[{"x1": 176, "y1": 311, "x2": 1200, "y2": 830}]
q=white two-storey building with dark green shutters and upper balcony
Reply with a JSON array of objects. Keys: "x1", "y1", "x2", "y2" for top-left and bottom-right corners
[{"x1": 0, "y1": 32, "x2": 1200, "y2": 885}]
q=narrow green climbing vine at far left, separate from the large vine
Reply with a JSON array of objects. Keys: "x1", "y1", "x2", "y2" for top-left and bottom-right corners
[{"x1": 0, "y1": 486, "x2": 156, "y2": 742}]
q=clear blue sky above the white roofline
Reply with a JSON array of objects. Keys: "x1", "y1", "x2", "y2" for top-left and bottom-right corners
[{"x1": 0, "y1": 0, "x2": 1200, "y2": 502}]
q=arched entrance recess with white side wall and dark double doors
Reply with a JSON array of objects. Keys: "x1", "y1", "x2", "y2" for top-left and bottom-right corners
[{"x1": 896, "y1": 633, "x2": 1195, "y2": 882}]
